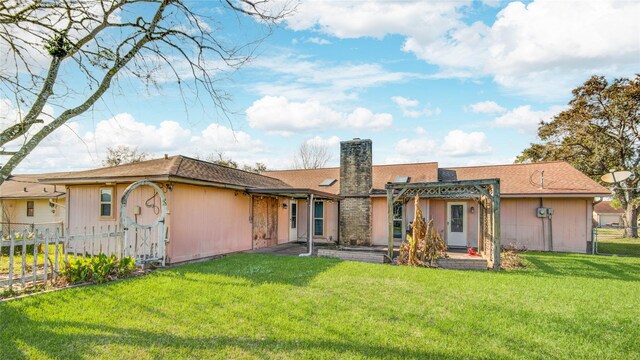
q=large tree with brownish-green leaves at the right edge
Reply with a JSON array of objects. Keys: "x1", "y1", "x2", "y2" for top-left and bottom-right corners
[{"x1": 516, "y1": 74, "x2": 640, "y2": 237}]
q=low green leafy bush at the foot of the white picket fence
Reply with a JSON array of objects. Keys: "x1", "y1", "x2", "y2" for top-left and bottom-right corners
[{"x1": 61, "y1": 254, "x2": 136, "y2": 284}]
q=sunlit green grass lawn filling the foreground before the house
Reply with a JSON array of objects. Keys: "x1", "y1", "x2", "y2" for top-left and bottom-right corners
[{"x1": 0, "y1": 253, "x2": 640, "y2": 359}]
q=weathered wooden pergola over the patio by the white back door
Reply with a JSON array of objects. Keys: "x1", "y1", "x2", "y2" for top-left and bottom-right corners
[{"x1": 385, "y1": 179, "x2": 500, "y2": 269}]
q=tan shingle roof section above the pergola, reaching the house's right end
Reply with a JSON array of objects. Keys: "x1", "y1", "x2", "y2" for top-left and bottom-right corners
[{"x1": 439, "y1": 161, "x2": 611, "y2": 196}]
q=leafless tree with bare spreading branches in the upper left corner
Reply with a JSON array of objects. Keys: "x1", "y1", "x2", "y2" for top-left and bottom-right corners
[{"x1": 0, "y1": 0, "x2": 293, "y2": 183}]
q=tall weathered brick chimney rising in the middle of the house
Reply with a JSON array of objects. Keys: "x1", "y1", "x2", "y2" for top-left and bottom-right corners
[{"x1": 340, "y1": 138, "x2": 373, "y2": 245}]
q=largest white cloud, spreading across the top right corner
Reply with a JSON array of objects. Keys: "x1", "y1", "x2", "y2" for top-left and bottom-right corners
[{"x1": 272, "y1": 0, "x2": 640, "y2": 99}]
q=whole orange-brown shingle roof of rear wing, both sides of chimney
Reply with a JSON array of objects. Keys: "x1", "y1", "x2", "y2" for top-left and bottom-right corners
[{"x1": 265, "y1": 161, "x2": 611, "y2": 196}]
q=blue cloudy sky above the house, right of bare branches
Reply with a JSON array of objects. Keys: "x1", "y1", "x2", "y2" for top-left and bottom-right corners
[{"x1": 5, "y1": 0, "x2": 640, "y2": 172}]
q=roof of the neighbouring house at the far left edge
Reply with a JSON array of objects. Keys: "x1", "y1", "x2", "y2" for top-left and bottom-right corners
[{"x1": 0, "y1": 174, "x2": 64, "y2": 199}]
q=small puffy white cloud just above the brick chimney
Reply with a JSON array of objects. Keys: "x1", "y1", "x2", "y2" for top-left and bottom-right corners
[{"x1": 246, "y1": 96, "x2": 393, "y2": 136}]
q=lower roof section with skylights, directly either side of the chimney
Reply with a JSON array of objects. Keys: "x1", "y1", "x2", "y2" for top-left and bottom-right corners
[{"x1": 264, "y1": 162, "x2": 438, "y2": 194}]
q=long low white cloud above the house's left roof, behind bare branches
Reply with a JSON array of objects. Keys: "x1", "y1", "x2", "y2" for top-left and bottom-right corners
[{"x1": 0, "y1": 104, "x2": 264, "y2": 173}]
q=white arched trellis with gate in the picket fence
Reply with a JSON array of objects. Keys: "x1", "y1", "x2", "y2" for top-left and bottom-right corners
[{"x1": 120, "y1": 180, "x2": 167, "y2": 266}]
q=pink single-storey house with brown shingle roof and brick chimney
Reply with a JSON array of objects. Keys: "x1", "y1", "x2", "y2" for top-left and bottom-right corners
[{"x1": 41, "y1": 139, "x2": 610, "y2": 263}]
